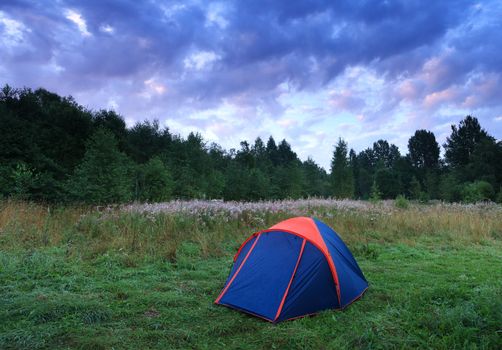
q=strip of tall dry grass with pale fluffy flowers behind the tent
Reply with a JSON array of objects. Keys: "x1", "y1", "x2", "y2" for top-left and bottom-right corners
[{"x1": 0, "y1": 201, "x2": 502, "y2": 260}]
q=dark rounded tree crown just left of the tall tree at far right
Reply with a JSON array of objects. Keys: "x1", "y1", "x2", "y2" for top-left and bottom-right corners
[{"x1": 408, "y1": 130, "x2": 439, "y2": 169}]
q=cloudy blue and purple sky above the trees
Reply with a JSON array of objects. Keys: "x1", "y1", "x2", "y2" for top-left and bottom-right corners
[{"x1": 0, "y1": 0, "x2": 502, "y2": 169}]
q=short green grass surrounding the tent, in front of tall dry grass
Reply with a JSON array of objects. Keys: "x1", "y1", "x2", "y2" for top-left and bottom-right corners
[{"x1": 0, "y1": 201, "x2": 502, "y2": 349}]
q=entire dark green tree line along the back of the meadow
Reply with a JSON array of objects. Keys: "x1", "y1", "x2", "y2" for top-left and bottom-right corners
[{"x1": 0, "y1": 85, "x2": 502, "y2": 204}]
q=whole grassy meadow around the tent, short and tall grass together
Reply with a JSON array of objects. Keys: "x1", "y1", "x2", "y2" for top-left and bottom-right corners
[{"x1": 0, "y1": 200, "x2": 502, "y2": 349}]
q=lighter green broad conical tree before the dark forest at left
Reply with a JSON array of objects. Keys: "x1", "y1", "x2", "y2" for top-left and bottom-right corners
[{"x1": 67, "y1": 128, "x2": 132, "y2": 204}]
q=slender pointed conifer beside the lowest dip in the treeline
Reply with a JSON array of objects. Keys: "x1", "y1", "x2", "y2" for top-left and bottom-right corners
[{"x1": 331, "y1": 138, "x2": 354, "y2": 198}]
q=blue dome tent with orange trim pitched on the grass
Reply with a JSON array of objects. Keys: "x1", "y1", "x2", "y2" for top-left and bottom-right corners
[{"x1": 215, "y1": 217, "x2": 368, "y2": 323}]
